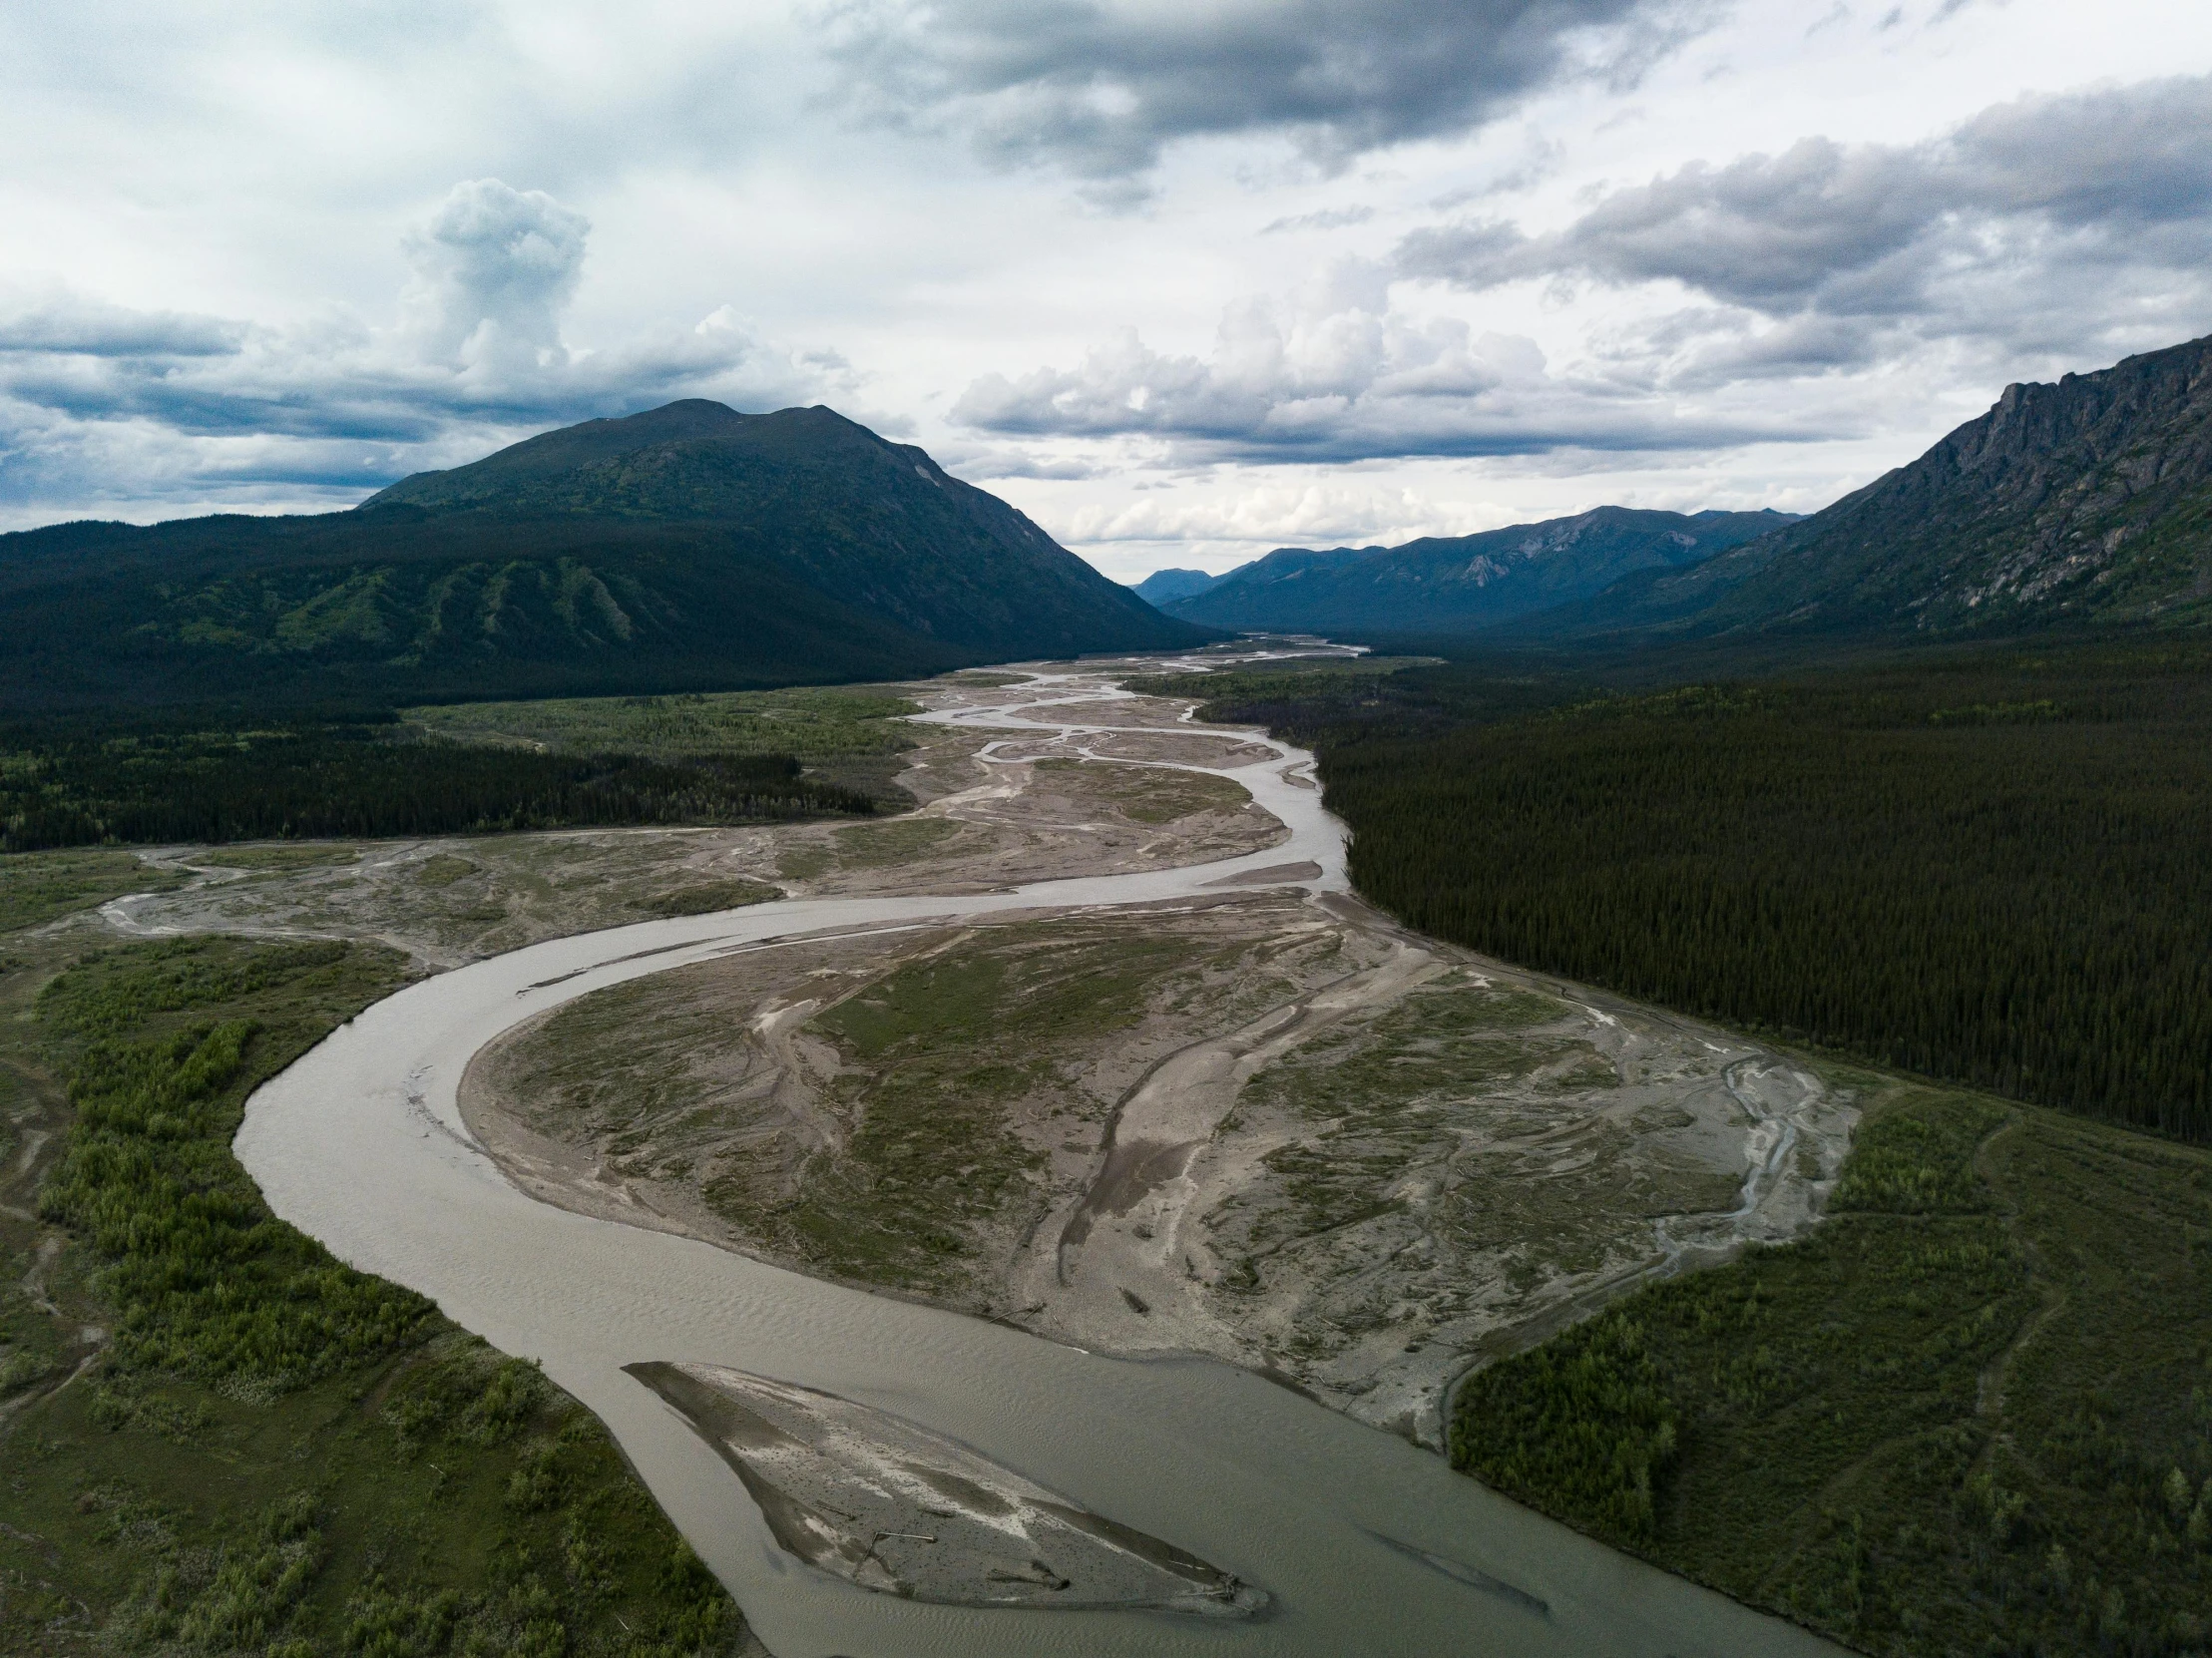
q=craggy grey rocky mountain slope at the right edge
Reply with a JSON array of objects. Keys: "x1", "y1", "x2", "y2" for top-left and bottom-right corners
[{"x1": 1529, "y1": 338, "x2": 2212, "y2": 641}]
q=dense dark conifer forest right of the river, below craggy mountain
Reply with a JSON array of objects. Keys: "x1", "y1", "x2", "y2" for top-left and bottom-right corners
[{"x1": 1207, "y1": 641, "x2": 2212, "y2": 1138}]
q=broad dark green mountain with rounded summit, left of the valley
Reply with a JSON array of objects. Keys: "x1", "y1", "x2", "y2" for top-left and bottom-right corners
[{"x1": 0, "y1": 400, "x2": 1210, "y2": 712}]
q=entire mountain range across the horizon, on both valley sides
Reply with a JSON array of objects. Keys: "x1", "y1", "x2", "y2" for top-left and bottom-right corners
[{"x1": 21, "y1": 338, "x2": 2212, "y2": 714}]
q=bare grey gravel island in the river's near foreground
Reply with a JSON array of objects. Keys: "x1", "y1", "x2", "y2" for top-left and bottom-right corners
[{"x1": 624, "y1": 1362, "x2": 1267, "y2": 1616}]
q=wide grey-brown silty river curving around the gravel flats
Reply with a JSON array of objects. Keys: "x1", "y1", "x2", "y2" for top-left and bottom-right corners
[{"x1": 236, "y1": 676, "x2": 1836, "y2": 1658}]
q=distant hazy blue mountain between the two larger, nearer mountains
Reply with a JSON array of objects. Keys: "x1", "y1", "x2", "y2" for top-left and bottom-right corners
[{"x1": 1163, "y1": 506, "x2": 1794, "y2": 632}]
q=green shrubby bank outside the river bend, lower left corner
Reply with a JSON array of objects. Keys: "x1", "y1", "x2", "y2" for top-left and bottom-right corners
[{"x1": 0, "y1": 940, "x2": 743, "y2": 1658}]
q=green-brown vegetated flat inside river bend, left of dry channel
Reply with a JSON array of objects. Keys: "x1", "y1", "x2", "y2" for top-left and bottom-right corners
[{"x1": 471, "y1": 910, "x2": 1247, "y2": 1296}]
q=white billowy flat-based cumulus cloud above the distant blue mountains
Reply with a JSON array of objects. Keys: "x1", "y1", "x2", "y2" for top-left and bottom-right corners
[{"x1": 951, "y1": 260, "x2": 1803, "y2": 462}]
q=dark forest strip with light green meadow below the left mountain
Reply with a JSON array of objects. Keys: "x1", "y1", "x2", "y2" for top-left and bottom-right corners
[{"x1": 0, "y1": 685, "x2": 938, "y2": 851}]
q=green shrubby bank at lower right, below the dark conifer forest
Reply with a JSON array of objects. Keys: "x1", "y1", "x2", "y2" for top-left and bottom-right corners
[{"x1": 1451, "y1": 1078, "x2": 2212, "y2": 1654}]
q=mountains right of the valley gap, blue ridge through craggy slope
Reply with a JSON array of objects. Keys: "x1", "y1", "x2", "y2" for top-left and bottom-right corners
[{"x1": 1139, "y1": 338, "x2": 2212, "y2": 645}]
